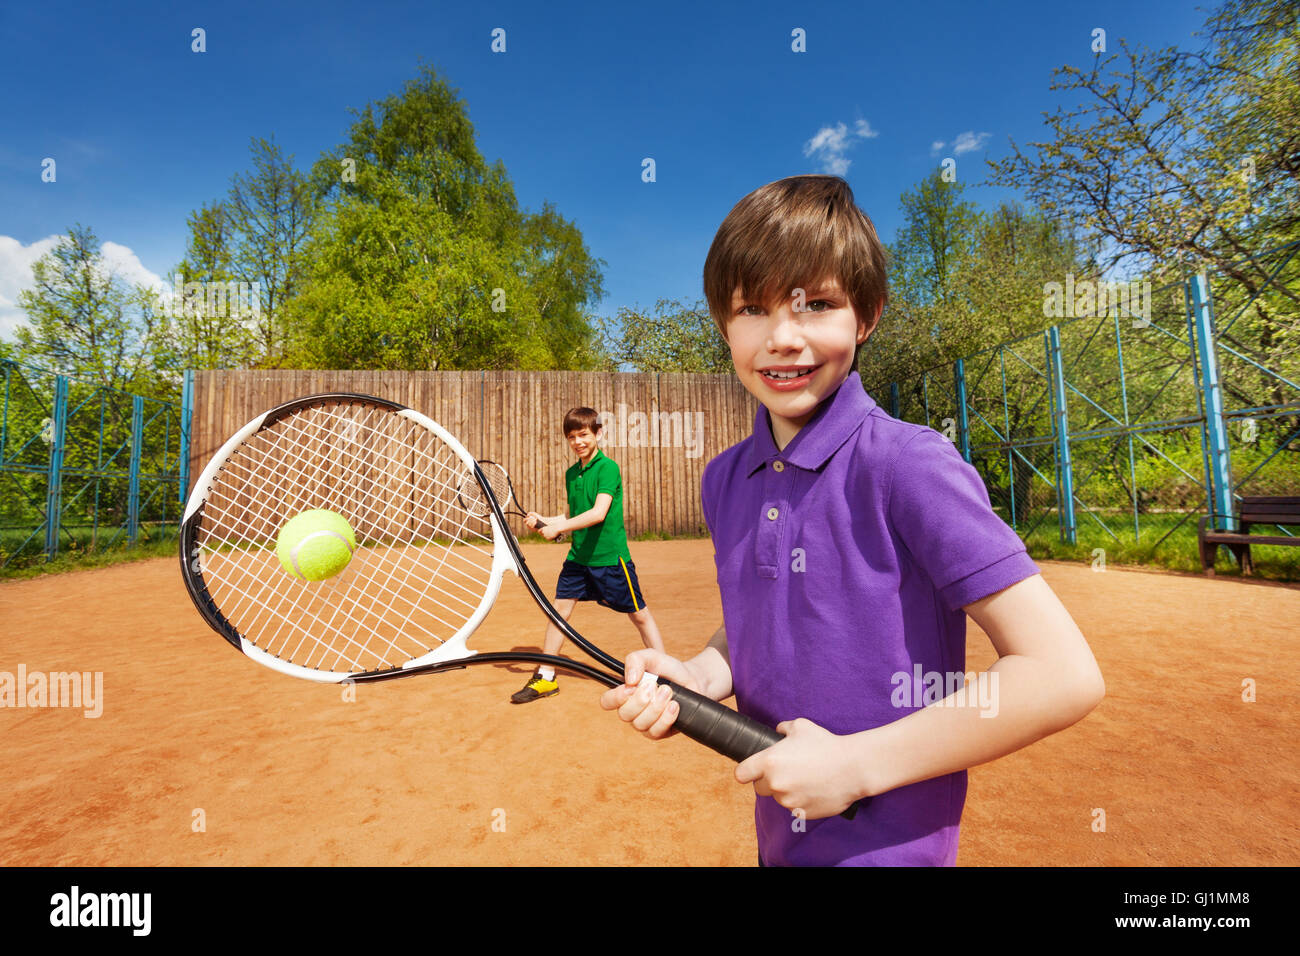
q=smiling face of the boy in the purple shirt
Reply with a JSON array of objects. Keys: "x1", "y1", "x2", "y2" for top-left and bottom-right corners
[{"x1": 727, "y1": 280, "x2": 875, "y2": 449}]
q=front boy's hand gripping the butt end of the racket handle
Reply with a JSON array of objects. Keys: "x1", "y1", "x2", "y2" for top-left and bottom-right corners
[{"x1": 736, "y1": 717, "x2": 865, "y2": 819}]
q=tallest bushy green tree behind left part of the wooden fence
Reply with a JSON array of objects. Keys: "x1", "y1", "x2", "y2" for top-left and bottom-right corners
[{"x1": 290, "y1": 69, "x2": 603, "y2": 369}]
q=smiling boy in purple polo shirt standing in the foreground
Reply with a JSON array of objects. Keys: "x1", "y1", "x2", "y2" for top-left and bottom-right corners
[{"x1": 601, "y1": 176, "x2": 1105, "y2": 865}]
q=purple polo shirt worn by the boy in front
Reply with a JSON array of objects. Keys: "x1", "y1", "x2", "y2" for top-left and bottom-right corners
[{"x1": 701, "y1": 372, "x2": 1039, "y2": 866}]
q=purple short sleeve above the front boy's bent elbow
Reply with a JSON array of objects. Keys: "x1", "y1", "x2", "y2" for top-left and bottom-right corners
[{"x1": 888, "y1": 429, "x2": 1039, "y2": 610}]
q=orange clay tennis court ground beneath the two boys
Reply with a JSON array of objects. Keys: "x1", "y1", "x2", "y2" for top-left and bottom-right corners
[{"x1": 0, "y1": 540, "x2": 1300, "y2": 866}]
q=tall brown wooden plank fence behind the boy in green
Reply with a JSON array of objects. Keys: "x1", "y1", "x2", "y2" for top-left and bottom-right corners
[{"x1": 187, "y1": 371, "x2": 757, "y2": 536}]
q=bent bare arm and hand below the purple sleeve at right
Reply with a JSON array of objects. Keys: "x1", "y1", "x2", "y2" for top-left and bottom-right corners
[{"x1": 736, "y1": 575, "x2": 1105, "y2": 818}]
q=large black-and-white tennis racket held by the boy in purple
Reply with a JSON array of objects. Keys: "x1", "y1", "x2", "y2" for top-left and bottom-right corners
[{"x1": 181, "y1": 393, "x2": 853, "y2": 816}]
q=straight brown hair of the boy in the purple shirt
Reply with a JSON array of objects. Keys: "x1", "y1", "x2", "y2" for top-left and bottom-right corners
[{"x1": 705, "y1": 176, "x2": 889, "y2": 363}]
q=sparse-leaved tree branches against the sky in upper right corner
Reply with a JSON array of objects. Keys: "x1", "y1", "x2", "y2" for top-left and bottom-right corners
[{"x1": 991, "y1": 0, "x2": 1300, "y2": 283}]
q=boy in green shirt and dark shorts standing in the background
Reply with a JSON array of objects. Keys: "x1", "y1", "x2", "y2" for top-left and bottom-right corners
[{"x1": 510, "y1": 407, "x2": 663, "y2": 704}]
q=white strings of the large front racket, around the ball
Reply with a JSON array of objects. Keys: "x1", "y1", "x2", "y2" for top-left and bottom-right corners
[{"x1": 199, "y1": 403, "x2": 493, "y2": 672}]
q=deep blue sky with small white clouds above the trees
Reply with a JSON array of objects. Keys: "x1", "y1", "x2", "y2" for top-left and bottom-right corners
[{"x1": 0, "y1": 0, "x2": 1205, "y2": 338}]
